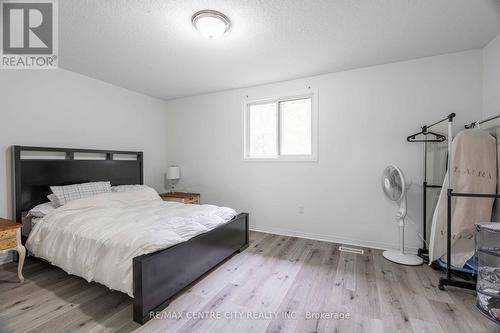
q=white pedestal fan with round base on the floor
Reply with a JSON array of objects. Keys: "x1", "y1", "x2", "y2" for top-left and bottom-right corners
[{"x1": 382, "y1": 165, "x2": 423, "y2": 266}]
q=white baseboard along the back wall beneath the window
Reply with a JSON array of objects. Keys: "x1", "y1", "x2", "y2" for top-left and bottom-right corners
[{"x1": 249, "y1": 225, "x2": 418, "y2": 254}]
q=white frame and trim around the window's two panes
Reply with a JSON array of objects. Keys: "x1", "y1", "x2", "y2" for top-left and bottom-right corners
[{"x1": 243, "y1": 89, "x2": 318, "y2": 162}]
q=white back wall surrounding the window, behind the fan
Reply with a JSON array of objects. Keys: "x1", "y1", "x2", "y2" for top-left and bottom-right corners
[{"x1": 166, "y1": 50, "x2": 482, "y2": 248}]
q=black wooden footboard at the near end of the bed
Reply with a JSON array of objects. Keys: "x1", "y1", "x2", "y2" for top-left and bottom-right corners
[{"x1": 133, "y1": 213, "x2": 248, "y2": 324}]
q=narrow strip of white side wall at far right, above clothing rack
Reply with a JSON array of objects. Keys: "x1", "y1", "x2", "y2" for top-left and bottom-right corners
[{"x1": 483, "y1": 35, "x2": 500, "y2": 117}]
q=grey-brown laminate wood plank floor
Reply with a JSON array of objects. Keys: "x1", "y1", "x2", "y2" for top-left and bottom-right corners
[{"x1": 0, "y1": 232, "x2": 500, "y2": 333}]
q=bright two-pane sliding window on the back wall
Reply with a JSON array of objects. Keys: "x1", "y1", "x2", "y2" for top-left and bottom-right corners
[{"x1": 244, "y1": 93, "x2": 317, "y2": 161}]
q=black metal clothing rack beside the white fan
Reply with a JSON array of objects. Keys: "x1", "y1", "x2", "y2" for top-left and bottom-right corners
[{"x1": 418, "y1": 113, "x2": 500, "y2": 290}]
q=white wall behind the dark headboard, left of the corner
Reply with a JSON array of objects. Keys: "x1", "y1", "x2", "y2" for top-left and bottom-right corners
[{"x1": 0, "y1": 70, "x2": 168, "y2": 260}]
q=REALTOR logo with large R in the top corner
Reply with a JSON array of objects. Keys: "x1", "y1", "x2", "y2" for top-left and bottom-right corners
[{"x1": 0, "y1": 0, "x2": 57, "y2": 69}]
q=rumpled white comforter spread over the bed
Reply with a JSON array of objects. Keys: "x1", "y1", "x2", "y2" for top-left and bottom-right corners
[{"x1": 26, "y1": 189, "x2": 236, "y2": 297}]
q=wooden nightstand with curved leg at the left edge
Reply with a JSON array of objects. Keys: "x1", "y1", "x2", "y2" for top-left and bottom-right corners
[{"x1": 0, "y1": 218, "x2": 26, "y2": 283}]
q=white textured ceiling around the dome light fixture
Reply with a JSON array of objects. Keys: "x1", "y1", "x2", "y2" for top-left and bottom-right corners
[{"x1": 59, "y1": 0, "x2": 500, "y2": 99}]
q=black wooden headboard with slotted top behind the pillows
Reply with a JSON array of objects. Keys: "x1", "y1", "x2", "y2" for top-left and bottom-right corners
[{"x1": 12, "y1": 146, "x2": 143, "y2": 222}]
